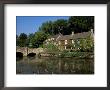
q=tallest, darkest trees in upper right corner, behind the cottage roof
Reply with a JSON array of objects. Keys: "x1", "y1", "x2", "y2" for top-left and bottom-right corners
[{"x1": 68, "y1": 16, "x2": 94, "y2": 33}]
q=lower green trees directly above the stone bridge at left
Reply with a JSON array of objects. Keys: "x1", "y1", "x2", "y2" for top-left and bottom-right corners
[{"x1": 16, "y1": 31, "x2": 47, "y2": 48}]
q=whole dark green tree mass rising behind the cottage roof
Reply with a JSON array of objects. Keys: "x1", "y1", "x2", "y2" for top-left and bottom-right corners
[{"x1": 39, "y1": 16, "x2": 94, "y2": 35}]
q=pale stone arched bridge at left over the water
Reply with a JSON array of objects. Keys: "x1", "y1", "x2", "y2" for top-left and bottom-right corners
[{"x1": 16, "y1": 47, "x2": 44, "y2": 56}]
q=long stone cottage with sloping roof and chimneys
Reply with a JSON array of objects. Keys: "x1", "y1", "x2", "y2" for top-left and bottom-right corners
[{"x1": 44, "y1": 29, "x2": 94, "y2": 50}]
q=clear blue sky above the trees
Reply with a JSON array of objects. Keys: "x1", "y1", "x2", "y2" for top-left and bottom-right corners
[{"x1": 16, "y1": 16, "x2": 69, "y2": 35}]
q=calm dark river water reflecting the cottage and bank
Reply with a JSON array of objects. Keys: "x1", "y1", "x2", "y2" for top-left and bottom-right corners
[{"x1": 16, "y1": 57, "x2": 94, "y2": 74}]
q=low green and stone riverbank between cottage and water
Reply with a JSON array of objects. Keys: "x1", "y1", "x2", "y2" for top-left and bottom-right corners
[{"x1": 38, "y1": 51, "x2": 94, "y2": 59}]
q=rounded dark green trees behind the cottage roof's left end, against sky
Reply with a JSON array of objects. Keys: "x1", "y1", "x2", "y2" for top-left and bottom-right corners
[{"x1": 39, "y1": 19, "x2": 68, "y2": 35}]
